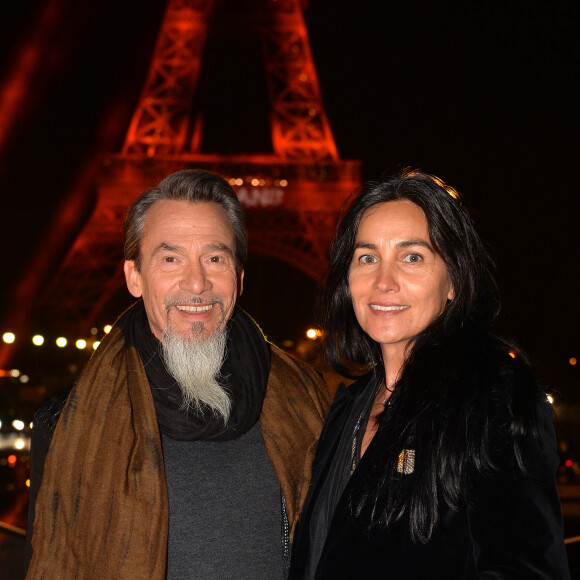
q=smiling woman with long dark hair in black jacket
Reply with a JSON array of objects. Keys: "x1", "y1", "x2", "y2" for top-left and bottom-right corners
[{"x1": 291, "y1": 171, "x2": 569, "y2": 580}]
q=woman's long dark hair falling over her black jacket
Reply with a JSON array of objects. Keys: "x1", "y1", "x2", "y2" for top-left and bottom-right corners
[{"x1": 322, "y1": 170, "x2": 537, "y2": 542}]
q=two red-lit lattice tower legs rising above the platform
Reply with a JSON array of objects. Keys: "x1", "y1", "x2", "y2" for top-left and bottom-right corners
[{"x1": 122, "y1": 0, "x2": 338, "y2": 162}]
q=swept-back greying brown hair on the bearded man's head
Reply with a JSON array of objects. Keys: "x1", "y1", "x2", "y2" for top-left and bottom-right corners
[{"x1": 123, "y1": 169, "x2": 248, "y2": 272}]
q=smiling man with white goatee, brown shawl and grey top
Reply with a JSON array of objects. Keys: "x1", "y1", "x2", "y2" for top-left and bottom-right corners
[{"x1": 27, "y1": 170, "x2": 329, "y2": 580}]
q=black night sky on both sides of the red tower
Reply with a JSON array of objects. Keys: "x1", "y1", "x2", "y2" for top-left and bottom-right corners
[{"x1": 0, "y1": 0, "x2": 580, "y2": 400}]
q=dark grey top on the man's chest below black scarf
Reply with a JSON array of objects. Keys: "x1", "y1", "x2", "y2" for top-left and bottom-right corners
[{"x1": 162, "y1": 421, "x2": 284, "y2": 580}]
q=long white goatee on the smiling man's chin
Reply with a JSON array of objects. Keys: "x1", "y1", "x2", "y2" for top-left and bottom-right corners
[{"x1": 161, "y1": 323, "x2": 232, "y2": 424}]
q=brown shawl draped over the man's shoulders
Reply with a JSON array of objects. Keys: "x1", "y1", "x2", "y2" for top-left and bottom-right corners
[{"x1": 26, "y1": 327, "x2": 329, "y2": 580}]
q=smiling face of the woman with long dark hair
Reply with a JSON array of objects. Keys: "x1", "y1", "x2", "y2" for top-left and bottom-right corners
[{"x1": 349, "y1": 200, "x2": 453, "y2": 361}]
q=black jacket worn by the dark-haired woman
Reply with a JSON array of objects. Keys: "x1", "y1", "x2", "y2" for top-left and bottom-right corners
[{"x1": 290, "y1": 346, "x2": 570, "y2": 580}]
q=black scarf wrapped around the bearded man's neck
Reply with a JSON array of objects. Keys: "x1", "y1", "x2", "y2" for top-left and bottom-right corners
[{"x1": 119, "y1": 301, "x2": 270, "y2": 441}]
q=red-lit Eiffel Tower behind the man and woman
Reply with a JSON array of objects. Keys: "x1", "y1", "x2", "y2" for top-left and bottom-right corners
[{"x1": 11, "y1": 0, "x2": 360, "y2": 344}]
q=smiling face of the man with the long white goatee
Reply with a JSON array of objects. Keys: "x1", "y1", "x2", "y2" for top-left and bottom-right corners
[{"x1": 125, "y1": 200, "x2": 244, "y2": 340}]
